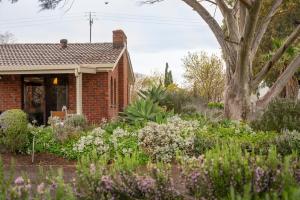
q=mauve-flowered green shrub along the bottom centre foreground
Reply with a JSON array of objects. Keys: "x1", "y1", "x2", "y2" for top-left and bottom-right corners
[{"x1": 76, "y1": 157, "x2": 183, "y2": 200}]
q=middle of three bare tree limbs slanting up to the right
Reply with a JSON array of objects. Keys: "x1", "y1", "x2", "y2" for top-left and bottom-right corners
[{"x1": 251, "y1": 25, "x2": 300, "y2": 89}]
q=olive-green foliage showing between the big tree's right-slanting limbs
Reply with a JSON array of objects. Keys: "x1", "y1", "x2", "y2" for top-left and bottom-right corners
[{"x1": 253, "y1": 0, "x2": 300, "y2": 96}]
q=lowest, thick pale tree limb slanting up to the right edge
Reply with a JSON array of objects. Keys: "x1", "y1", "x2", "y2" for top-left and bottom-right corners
[{"x1": 256, "y1": 55, "x2": 300, "y2": 108}]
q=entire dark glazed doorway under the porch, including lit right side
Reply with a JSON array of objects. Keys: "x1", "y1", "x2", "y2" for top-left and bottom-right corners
[{"x1": 23, "y1": 75, "x2": 68, "y2": 125}]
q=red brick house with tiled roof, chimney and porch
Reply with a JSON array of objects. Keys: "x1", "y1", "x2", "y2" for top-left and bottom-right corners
[{"x1": 0, "y1": 30, "x2": 134, "y2": 123}]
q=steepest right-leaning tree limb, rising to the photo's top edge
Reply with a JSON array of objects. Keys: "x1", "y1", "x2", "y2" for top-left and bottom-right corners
[{"x1": 252, "y1": 0, "x2": 283, "y2": 57}]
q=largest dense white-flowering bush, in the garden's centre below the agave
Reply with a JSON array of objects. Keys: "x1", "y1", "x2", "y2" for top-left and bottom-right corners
[{"x1": 138, "y1": 116, "x2": 199, "y2": 162}]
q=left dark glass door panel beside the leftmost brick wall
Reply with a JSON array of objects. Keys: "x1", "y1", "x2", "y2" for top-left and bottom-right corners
[{"x1": 23, "y1": 76, "x2": 46, "y2": 124}]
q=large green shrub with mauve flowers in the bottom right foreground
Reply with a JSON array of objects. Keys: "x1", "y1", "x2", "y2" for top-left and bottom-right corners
[{"x1": 183, "y1": 143, "x2": 299, "y2": 199}]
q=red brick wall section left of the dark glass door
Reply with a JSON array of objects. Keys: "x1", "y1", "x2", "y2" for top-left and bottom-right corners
[{"x1": 0, "y1": 75, "x2": 22, "y2": 111}]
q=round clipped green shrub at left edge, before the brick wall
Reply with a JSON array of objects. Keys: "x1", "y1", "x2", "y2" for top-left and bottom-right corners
[{"x1": 0, "y1": 109, "x2": 29, "y2": 153}]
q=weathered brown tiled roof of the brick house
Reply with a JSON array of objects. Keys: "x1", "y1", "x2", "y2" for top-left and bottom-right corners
[{"x1": 0, "y1": 43, "x2": 122, "y2": 67}]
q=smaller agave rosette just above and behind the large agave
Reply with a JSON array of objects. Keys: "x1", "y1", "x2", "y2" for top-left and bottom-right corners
[{"x1": 138, "y1": 84, "x2": 167, "y2": 105}]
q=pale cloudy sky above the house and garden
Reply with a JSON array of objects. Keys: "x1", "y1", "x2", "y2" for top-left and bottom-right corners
[{"x1": 0, "y1": 0, "x2": 221, "y2": 84}]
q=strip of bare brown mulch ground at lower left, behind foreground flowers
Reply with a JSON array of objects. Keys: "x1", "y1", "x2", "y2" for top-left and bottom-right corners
[{"x1": 0, "y1": 153, "x2": 76, "y2": 182}]
